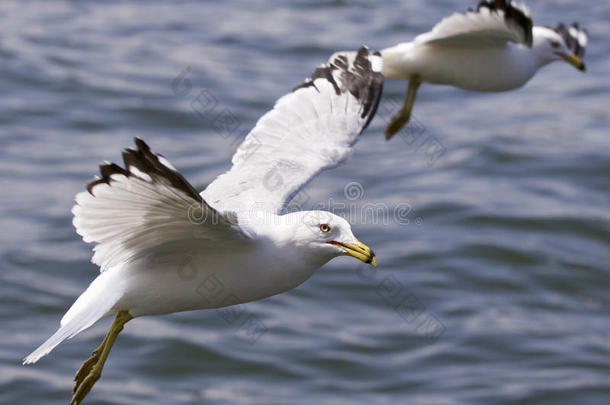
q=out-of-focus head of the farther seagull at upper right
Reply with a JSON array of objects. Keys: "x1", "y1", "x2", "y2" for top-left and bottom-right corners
[{"x1": 533, "y1": 23, "x2": 587, "y2": 72}]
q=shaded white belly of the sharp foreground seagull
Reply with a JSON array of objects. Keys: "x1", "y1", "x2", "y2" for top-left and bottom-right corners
[{"x1": 108, "y1": 240, "x2": 324, "y2": 316}]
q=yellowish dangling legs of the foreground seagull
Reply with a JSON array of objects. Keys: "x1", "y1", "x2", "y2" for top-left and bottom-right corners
[{"x1": 70, "y1": 311, "x2": 132, "y2": 405}]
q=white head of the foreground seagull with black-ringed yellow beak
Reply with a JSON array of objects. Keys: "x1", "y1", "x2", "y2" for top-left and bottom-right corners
[{"x1": 284, "y1": 211, "x2": 377, "y2": 266}]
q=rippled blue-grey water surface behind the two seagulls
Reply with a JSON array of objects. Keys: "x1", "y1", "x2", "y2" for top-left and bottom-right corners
[{"x1": 0, "y1": 0, "x2": 610, "y2": 404}]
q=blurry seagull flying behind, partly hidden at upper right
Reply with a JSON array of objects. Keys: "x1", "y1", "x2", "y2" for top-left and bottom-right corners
[{"x1": 344, "y1": 0, "x2": 587, "y2": 139}]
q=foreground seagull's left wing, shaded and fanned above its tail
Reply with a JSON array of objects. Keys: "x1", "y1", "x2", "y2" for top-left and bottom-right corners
[{"x1": 72, "y1": 138, "x2": 239, "y2": 272}]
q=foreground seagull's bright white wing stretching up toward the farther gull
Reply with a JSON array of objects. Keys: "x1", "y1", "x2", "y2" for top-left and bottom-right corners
[{"x1": 202, "y1": 47, "x2": 383, "y2": 214}]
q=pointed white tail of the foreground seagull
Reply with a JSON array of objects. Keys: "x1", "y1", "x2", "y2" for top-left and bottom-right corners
[{"x1": 23, "y1": 272, "x2": 122, "y2": 364}]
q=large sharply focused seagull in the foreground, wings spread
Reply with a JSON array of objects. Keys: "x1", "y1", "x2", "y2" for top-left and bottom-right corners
[{"x1": 23, "y1": 47, "x2": 383, "y2": 405}]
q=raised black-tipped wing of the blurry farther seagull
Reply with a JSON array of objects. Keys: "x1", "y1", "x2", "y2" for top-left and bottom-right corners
[{"x1": 414, "y1": 0, "x2": 533, "y2": 47}]
